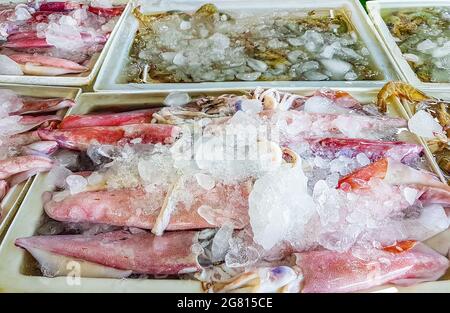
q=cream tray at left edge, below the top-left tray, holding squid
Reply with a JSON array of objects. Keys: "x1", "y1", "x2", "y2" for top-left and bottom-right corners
[{"x1": 0, "y1": 84, "x2": 81, "y2": 242}]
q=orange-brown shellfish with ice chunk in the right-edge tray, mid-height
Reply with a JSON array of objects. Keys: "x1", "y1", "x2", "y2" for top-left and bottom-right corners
[{"x1": 379, "y1": 82, "x2": 450, "y2": 178}]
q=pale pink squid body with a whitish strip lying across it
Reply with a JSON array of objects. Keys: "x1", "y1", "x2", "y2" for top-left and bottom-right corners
[{"x1": 43, "y1": 180, "x2": 251, "y2": 235}]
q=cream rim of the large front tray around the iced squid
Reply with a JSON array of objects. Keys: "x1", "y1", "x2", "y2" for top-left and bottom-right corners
[{"x1": 0, "y1": 87, "x2": 450, "y2": 293}]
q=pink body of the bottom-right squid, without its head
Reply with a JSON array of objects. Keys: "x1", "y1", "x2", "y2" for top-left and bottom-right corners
[{"x1": 295, "y1": 243, "x2": 449, "y2": 293}]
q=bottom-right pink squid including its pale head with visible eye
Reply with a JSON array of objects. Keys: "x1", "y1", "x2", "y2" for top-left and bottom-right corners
[{"x1": 208, "y1": 241, "x2": 449, "y2": 293}]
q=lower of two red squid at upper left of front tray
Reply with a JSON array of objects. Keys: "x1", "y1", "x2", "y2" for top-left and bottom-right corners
[{"x1": 38, "y1": 124, "x2": 181, "y2": 151}]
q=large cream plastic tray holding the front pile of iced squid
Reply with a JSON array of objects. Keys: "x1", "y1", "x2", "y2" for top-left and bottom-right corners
[{"x1": 0, "y1": 88, "x2": 450, "y2": 293}]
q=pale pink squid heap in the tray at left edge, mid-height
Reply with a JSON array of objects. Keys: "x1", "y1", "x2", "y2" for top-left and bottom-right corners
[{"x1": 0, "y1": 89, "x2": 74, "y2": 220}]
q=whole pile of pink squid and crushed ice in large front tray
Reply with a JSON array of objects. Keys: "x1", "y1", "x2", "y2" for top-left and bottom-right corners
[{"x1": 13, "y1": 84, "x2": 450, "y2": 292}]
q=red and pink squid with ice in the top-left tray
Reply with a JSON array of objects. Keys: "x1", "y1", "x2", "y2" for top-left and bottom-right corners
[{"x1": 0, "y1": 0, "x2": 124, "y2": 76}]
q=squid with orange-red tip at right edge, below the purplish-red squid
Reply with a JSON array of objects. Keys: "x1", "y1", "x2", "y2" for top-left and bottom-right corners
[{"x1": 337, "y1": 158, "x2": 450, "y2": 206}]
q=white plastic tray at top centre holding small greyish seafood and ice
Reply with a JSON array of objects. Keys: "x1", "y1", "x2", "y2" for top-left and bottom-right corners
[{"x1": 94, "y1": 0, "x2": 398, "y2": 91}]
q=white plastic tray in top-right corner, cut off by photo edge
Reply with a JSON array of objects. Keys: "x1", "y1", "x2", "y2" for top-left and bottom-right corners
[{"x1": 366, "y1": 0, "x2": 450, "y2": 91}]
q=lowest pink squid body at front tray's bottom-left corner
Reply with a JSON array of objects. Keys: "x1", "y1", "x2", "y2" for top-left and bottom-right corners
[{"x1": 15, "y1": 231, "x2": 201, "y2": 275}]
